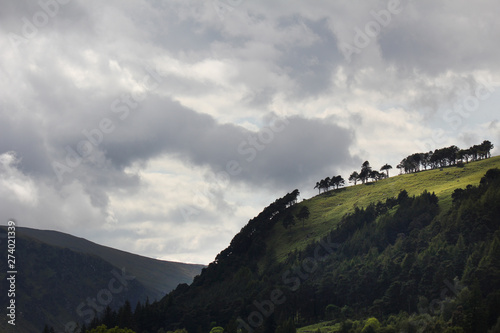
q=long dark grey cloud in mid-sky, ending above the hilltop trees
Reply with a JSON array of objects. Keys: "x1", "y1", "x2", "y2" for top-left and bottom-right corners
[{"x1": 77, "y1": 97, "x2": 360, "y2": 192}]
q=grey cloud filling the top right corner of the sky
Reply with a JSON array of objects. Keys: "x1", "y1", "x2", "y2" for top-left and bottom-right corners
[{"x1": 379, "y1": 1, "x2": 500, "y2": 75}]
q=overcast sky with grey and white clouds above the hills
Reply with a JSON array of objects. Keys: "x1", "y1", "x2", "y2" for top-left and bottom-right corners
[{"x1": 0, "y1": 0, "x2": 500, "y2": 264}]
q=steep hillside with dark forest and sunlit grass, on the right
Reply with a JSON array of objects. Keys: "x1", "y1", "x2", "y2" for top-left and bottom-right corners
[{"x1": 56, "y1": 157, "x2": 500, "y2": 333}]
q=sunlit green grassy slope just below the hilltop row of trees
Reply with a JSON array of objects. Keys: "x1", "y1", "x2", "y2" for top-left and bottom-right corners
[{"x1": 267, "y1": 156, "x2": 500, "y2": 261}]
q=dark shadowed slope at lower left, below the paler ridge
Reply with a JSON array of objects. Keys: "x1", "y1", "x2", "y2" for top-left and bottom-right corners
[{"x1": 0, "y1": 232, "x2": 148, "y2": 333}]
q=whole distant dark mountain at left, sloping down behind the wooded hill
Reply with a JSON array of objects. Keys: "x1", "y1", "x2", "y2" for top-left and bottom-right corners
[{"x1": 0, "y1": 227, "x2": 204, "y2": 333}]
